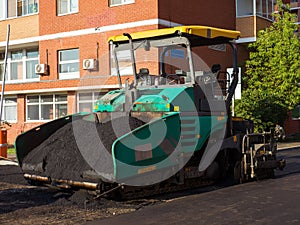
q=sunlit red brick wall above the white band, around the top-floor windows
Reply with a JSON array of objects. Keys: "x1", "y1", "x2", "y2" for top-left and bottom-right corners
[{"x1": 40, "y1": 0, "x2": 157, "y2": 35}]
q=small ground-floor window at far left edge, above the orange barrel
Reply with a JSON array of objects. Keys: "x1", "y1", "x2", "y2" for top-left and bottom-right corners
[{"x1": 2, "y1": 97, "x2": 17, "y2": 122}]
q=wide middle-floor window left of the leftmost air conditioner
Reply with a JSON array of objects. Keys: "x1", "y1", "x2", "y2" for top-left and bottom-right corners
[{"x1": 0, "y1": 48, "x2": 39, "y2": 82}]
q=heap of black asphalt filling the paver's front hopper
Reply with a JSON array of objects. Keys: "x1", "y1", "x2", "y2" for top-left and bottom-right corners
[{"x1": 22, "y1": 117, "x2": 144, "y2": 181}]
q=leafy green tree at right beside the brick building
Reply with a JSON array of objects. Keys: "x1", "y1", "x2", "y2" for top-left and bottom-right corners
[{"x1": 235, "y1": 0, "x2": 300, "y2": 131}]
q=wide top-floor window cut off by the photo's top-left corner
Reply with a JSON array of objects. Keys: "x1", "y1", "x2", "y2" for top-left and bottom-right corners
[{"x1": 0, "y1": 0, "x2": 38, "y2": 20}]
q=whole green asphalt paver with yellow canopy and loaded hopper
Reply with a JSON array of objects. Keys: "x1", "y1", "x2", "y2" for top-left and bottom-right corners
[{"x1": 15, "y1": 26, "x2": 284, "y2": 197}]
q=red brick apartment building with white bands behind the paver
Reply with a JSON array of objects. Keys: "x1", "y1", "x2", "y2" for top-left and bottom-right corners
[{"x1": 0, "y1": 0, "x2": 299, "y2": 144}]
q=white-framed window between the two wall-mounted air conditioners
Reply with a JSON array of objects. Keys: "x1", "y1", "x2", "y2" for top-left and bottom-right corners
[{"x1": 58, "y1": 49, "x2": 79, "y2": 79}]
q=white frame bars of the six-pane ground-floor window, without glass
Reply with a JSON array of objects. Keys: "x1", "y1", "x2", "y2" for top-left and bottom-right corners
[{"x1": 26, "y1": 93, "x2": 68, "y2": 122}]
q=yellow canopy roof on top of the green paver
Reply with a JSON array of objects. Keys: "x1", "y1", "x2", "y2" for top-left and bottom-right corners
[{"x1": 108, "y1": 26, "x2": 241, "y2": 42}]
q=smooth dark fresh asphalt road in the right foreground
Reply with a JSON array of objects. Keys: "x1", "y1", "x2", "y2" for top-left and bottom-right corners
[{"x1": 88, "y1": 148, "x2": 300, "y2": 225}]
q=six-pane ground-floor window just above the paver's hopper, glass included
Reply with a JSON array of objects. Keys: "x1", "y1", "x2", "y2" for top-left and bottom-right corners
[{"x1": 26, "y1": 94, "x2": 68, "y2": 121}]
